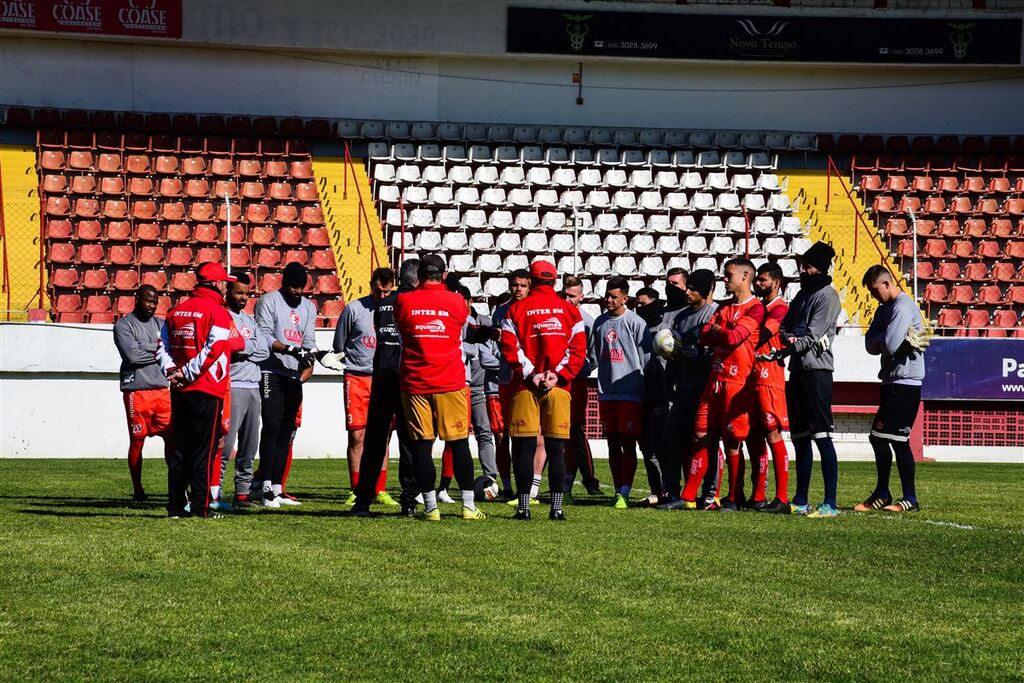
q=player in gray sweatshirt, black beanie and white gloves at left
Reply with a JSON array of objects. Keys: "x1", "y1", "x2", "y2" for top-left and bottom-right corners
[{"x1": 256, "y1": 261, "x2": 316, "y2": 508}]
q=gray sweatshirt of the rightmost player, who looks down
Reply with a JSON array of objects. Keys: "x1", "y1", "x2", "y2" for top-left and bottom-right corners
[{"x1": 864, "y1": 292, "x2": 925, "y2": 386}]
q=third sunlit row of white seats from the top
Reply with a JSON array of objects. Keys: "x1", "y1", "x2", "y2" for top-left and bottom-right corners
[{"x1": 378, "y1": 185, "x2": 793, "y2": 213}]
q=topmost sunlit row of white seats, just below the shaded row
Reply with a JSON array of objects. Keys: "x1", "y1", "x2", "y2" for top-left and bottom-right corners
[{"x1": 367, "y1": 142, "x2": 778, "y2": 169}]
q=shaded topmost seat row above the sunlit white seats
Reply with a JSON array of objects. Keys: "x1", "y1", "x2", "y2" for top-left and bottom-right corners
[{"x1": 352, "y1": 121, "x2": 815, "y2": 150}]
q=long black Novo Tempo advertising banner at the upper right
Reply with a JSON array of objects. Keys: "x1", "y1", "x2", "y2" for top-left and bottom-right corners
[{"x1": 508, "y1": 7, "x2": 1022, "y2": 65}]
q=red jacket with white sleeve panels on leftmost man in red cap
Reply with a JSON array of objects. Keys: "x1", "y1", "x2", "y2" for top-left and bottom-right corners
[{"x1": 157, "y1": 287, "x2": 246, "y2": 398}]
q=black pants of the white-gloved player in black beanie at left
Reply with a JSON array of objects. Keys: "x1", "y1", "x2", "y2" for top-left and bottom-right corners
[{"x1": 259, "y1": 373, "x2": 302, "y2": 484}]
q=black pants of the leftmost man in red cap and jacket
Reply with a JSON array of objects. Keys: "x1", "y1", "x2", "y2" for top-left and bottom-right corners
[{"x1": 167, "y1": 391, "x2": 224, "y2": 517}]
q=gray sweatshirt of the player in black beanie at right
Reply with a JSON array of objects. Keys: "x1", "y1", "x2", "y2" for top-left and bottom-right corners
[{"x1": 782, "y1": 285, "x2": 842, "y2": 373}]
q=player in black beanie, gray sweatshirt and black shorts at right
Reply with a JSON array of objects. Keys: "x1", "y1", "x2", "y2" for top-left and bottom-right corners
[{"x1": 773, "y1": 242, "x2": 842, "y2": 517}]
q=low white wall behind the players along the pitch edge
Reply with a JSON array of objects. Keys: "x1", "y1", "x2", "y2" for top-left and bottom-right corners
[{"x1": 0, "y1": 324, "x2": 1007, "y2": 462}]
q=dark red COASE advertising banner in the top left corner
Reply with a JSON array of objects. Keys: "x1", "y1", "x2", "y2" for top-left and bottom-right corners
[{"x1": 0, "y1": 0, "x2": 181, "y2": 38}]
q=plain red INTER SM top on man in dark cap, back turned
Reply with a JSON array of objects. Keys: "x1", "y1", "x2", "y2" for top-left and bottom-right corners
[{"x1": 394, "y1": 283, "x2": 469, "y2": 394}]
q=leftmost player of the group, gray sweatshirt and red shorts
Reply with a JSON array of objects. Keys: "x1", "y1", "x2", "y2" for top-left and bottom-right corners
[{"x1": 114, "y1": 285, "x2": 174, "y2": 502}]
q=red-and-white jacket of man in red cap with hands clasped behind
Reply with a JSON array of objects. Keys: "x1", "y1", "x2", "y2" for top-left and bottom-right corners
[{"x1": 502, "y1": 285, "x2": 587, "y2": 390}]
